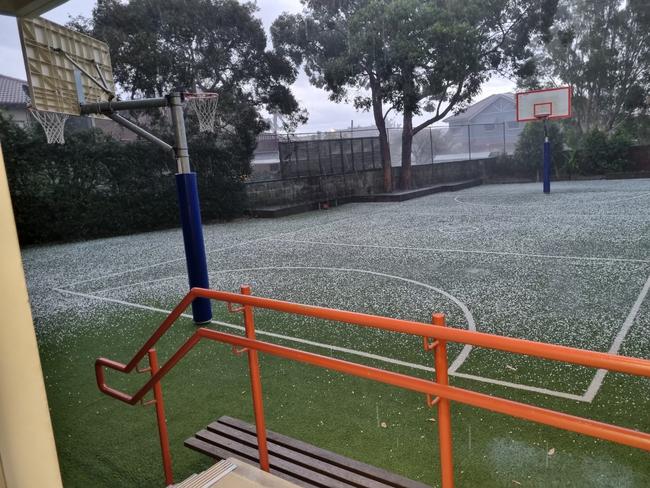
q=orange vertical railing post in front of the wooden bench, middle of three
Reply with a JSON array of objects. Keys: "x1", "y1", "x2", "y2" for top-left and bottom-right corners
[{"x1": 240, "y1": 285, "x2": 269, "y2": 472}]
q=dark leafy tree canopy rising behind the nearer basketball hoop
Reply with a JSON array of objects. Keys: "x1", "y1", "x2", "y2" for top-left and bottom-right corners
[{"x1": 70, "y1": 0, "x2": 305, "y2": 137}]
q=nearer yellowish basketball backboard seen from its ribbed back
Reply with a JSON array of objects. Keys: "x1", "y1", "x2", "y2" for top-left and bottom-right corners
[{"x1": 18, "y1": 17, "x2": 115, "y2": 115}]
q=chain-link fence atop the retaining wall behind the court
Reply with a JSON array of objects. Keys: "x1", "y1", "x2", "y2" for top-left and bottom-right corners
[{"x1": 251, "y1": 122, "x2": 524, "y2": 181}]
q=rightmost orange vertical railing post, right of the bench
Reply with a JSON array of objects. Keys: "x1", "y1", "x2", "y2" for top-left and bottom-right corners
[{"x1": 432, "y1": 313, "x2": 454, "y2": 488}]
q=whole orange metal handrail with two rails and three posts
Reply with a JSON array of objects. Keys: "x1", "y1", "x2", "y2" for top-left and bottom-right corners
[{"x1": 95, "y1": 286, "x2": 650, "y2": 488}]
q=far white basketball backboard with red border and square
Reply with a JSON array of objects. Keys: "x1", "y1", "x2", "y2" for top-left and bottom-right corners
[{"x1": 516, "y1": 86, "x2": 571, "y2": 122}]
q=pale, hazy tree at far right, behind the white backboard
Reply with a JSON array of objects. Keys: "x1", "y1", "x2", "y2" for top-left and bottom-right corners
[{"x1": 521, "y1": 0, "x2": 650, "y2": 136}]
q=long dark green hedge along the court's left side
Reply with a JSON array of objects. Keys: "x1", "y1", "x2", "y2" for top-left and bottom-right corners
[{"x1": 0, "y1": 113, "x2": 250, "y2": 245}]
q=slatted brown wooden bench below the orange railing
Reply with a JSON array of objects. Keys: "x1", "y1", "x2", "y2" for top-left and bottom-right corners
[{"x1": 185, "y1": 417, "x2": 427, "y2": 488}]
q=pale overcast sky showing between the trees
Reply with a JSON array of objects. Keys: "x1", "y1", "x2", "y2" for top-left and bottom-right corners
[{"x1": 0, "y1": 0, "x2": 514, "y2": 132}]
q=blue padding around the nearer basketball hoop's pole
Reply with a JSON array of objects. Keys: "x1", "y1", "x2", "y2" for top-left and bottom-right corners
[{"x1": 176, "y1": 173, "x2": 212, "y2": 324}]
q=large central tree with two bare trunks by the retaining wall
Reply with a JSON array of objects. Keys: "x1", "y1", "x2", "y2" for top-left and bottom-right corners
[{"x1": 272, "y1": 0, "x2": 557, "y2": 190}]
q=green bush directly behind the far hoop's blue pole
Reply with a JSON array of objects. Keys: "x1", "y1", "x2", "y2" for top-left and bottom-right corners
[{"x1": 515, "y1": 122, "x2": 564, "y2": 171}]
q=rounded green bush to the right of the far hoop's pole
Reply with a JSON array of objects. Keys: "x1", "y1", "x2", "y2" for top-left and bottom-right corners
[{"x1": 578, "y1": 129, "x2": 632, "y2": 174}]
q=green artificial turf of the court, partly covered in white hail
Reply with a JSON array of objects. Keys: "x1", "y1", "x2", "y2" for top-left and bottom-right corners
[{"x1": 24, "y1": 180, "x2": 650, "y2": 487}]
